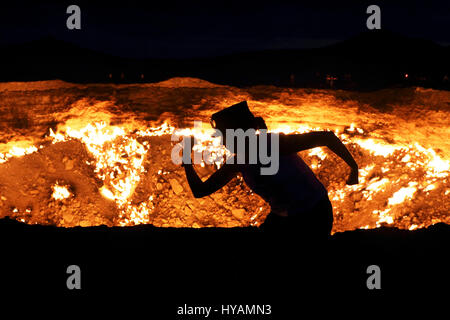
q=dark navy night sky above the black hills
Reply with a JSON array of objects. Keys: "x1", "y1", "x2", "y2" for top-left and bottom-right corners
[{"x1": 0, "y1": 0, "x2": 450, "y2": 58}]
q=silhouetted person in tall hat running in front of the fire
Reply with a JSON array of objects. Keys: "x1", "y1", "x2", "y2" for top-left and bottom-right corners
[{"x1": 183, "y1": 101, "x2": 358, "y2": 238}]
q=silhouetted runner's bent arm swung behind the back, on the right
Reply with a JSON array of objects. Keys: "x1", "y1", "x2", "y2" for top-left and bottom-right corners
[{"x1": 280, "y1": 131, "x2": 358, "y2": 184}]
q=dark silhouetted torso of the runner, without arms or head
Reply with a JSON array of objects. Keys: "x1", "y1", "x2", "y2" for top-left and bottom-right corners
[{"x1": 241, "y1": 153, "x2": 333, "y2": 238}]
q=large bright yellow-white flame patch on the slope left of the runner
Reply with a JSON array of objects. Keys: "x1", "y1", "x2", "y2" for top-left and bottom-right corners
[{"x1": 49, "y1": 122, "x2": 174, "y2": 225}]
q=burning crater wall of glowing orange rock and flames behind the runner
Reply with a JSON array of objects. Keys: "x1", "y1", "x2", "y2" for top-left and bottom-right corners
[{"x1": 0, "y1": 78, "x2": 450, "y2": 232}]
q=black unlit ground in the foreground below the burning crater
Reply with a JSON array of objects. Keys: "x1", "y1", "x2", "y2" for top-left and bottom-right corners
[{"x1": 0, "y1": 218, "x2": 450, "y2": 319}]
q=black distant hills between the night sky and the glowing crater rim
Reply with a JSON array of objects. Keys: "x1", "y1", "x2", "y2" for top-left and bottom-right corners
[{"x1": 0, "y1": 30, "x2": 450, "y2": 89}]
